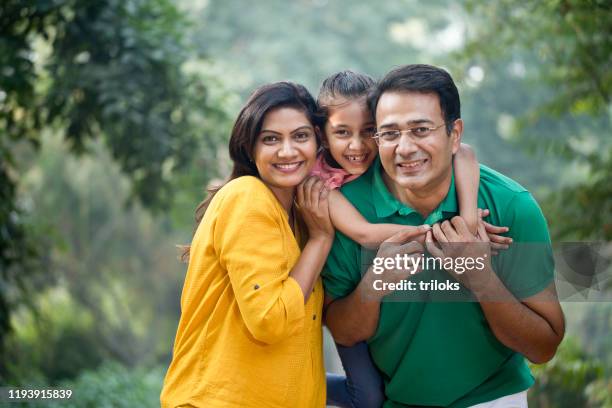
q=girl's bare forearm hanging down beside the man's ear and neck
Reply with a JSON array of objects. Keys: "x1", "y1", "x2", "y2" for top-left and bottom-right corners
[{"x1": 453, "y1": 143, "x2": 480, "y2": 235}]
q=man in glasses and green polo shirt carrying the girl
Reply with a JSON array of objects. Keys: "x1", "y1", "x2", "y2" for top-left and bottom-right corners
[{"x1": 323, "y1": 65, "x2": 564, "y2": 408}]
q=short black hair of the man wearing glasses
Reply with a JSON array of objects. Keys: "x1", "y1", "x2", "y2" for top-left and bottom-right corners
[{"x1": 368, "y1": 64, "x2": 461, "y2": 135}]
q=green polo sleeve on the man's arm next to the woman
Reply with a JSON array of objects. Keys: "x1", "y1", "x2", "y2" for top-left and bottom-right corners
[{"x1": 321, "y1": 231, "x2": 361, "y2": 299}]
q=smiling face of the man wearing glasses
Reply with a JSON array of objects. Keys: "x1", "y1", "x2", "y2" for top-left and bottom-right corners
[{"x1": 376, "y1": 92, "x2": 462, "y2": 193}]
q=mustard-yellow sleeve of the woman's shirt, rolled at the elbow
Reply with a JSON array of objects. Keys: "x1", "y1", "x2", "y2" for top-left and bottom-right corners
[{"x1": 214, "y1": 182, "x2": 305, "y2": 344}]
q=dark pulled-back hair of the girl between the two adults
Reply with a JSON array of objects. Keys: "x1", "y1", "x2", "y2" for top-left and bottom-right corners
[{"x1": 317, "y1": 70, "x2": 376, "y2": 167}]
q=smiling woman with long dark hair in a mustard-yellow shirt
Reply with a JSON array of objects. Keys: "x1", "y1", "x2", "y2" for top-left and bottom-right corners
[{"x1": 161, "y1": 82, "x2": 334, "y2": 408}]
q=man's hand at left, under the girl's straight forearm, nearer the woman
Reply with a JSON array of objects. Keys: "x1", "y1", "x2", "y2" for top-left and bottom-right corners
[{"x1": 360, "y1": 229, "x2": 424, "y2": 300}]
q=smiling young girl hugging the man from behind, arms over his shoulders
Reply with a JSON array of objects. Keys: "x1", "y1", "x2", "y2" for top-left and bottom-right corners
[{"x1": 312, "y1": 71, "x2": 509, "y2": 407}]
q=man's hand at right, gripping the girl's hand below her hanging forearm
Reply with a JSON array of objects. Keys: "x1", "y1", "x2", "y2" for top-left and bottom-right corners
[{"x1": 425, "y1": 216, "x2": 494, "y2": 295}]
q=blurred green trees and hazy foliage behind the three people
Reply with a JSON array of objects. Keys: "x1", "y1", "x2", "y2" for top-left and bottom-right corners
[{"x1": 0, "y1": 0, "x2": 612, "y2": 407}]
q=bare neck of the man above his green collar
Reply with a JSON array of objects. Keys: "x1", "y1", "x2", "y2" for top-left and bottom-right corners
[{"x1": 382, "y1": 167, "x2": 453, "y2": 218}]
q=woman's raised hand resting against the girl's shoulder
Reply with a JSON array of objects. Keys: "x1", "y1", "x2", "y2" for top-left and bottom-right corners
[{"x1": 297, "y1": 176, "x2": 334, "y2": 239}]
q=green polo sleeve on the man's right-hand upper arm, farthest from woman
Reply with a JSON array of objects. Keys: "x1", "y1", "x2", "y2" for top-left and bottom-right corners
[{"x1": 496, "y1": 191, "x2": 555, "y2": 299}]
